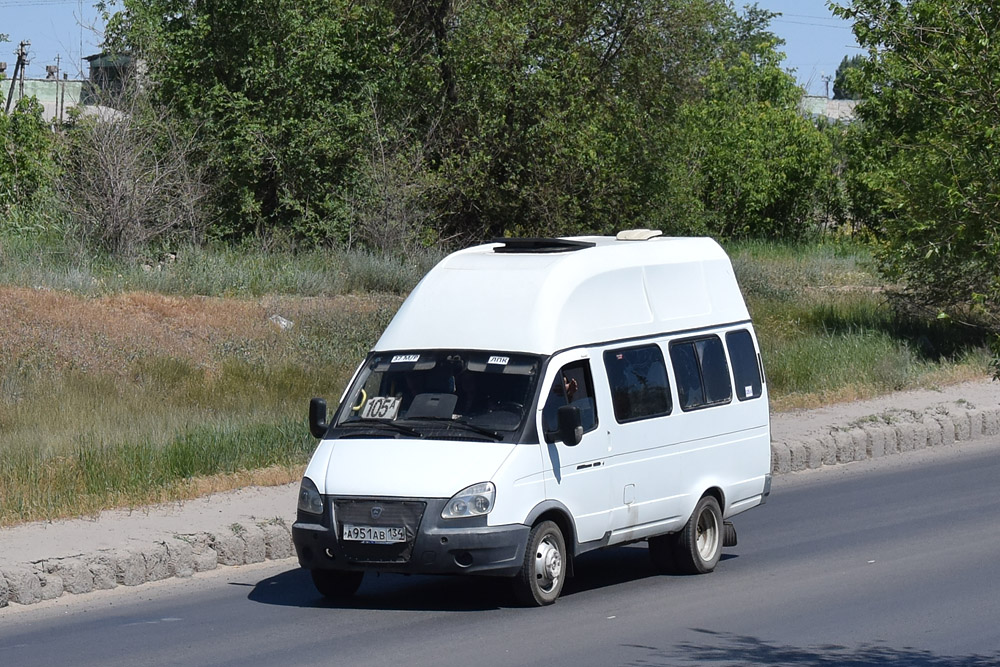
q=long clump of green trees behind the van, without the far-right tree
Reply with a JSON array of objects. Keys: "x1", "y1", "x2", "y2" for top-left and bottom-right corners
[{"x1": 99, "y1": 0, "x2": 829, "y2": 248}]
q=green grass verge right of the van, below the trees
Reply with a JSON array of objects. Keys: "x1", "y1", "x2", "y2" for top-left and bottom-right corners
[{"x1": 729, "y1": 243, "x2": 990, "y2": 409}]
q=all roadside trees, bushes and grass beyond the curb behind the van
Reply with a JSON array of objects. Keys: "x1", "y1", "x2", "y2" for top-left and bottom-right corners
[{"x1": 0, "y1": 0, "x2": 1000, "y2": 525}]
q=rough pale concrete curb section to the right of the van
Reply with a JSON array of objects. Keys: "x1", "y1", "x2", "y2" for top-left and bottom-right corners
[{"x1": 771, "y1": 408, "x2": 1000, "y2": 475}]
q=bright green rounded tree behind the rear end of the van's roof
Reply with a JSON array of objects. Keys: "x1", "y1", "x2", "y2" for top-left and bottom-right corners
[{"x1": 664, "y1": 16, "x2": 833, "y2": 239}]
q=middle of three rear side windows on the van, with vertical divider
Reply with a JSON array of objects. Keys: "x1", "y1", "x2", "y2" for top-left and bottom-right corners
[{"x1": 670, "y1": 336, "x2": 733, "y2": 411}]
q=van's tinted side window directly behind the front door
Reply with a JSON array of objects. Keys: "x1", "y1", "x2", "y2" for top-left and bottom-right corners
[{"x1": 604, "y1": 345, "x2": 671, "y2": 424}]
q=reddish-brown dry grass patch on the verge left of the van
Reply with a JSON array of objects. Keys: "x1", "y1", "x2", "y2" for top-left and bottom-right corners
[{"x1": 0, "y1": 287, "x2": 386, "y2": 373}]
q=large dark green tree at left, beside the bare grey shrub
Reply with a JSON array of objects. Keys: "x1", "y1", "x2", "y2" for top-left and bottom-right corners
[{"x1": 109, "y1": 0, "x2": 407, "y2": 244}]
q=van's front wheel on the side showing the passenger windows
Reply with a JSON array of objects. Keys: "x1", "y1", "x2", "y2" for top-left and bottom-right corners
[{"x1": 513, "y1": 521, "x2": 567, "y2": 607}]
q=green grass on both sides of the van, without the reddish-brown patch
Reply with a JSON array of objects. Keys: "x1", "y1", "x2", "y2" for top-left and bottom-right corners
[{"x1": 0, "y1": 237, "x2": 989, "y2": 525}]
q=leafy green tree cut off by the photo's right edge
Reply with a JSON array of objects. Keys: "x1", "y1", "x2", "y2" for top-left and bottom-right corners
[{"x1": 835, "y1": 0, "x2": 1000, "y2": 344}]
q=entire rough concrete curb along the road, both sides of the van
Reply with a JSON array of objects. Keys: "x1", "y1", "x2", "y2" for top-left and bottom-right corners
[{"x1": 0, "y1": 407, "x2": 1000, "y2": 608}]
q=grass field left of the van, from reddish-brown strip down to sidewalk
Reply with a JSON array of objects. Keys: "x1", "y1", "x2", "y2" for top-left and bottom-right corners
[{"x1": 0, "y1": 288, "x2": 401, "y2": 525}]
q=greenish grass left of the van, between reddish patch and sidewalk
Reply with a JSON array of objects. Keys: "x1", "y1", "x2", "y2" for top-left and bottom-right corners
[{"x1": 0, "y1": 298, "x2": 399, "y2": 525}]
